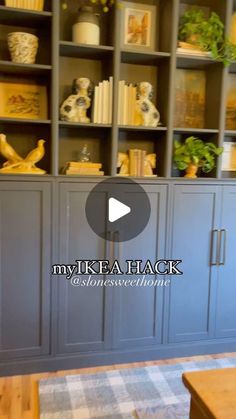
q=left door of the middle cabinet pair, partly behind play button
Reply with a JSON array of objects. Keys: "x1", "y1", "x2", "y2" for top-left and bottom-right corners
[{"x1": 58, "y1": 183, "x2": 111, "y2": 353}]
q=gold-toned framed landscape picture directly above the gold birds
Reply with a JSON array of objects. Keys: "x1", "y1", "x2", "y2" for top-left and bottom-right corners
[{"x1": 0, "y1": 81, "x2": 48, "y2": 119}]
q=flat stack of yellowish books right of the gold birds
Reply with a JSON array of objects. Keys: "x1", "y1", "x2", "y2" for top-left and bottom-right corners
[{"x1": 64, "y1": 161, "x2": 104, "y2": 176}]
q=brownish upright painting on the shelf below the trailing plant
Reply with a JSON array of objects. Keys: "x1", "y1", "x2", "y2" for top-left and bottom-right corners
[{"x1": 174, "y1": 69, "x2": 206, "y2": 128}]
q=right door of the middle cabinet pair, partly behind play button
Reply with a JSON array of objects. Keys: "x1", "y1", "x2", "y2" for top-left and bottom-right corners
[{"x1": 113, "y1": 185, "x2": 167, "y2": 348}]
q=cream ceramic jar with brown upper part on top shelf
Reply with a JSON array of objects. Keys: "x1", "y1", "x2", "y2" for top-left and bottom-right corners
[{"x1": 72, "y1": 6, "x2": 100, "y2": 45}]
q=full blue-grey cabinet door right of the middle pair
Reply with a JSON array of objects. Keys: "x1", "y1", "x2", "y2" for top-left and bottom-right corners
[{"x1": 169, "y1": 185, "x2": 221, "y2": 342}]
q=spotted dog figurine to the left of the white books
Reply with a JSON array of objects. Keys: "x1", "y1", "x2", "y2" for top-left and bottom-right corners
[{"x1": 60, "y1": 77, "x2": 94, "y2": 124}]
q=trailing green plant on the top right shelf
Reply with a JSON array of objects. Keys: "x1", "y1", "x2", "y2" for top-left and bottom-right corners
[{"x1": 179, "y1": 7, "x2": 236, "y2": 66}]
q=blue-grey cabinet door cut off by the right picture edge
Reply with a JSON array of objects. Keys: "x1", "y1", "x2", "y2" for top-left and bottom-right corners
[{"x1": 216, "y1": 186, "x2": 236, "y2": 337}]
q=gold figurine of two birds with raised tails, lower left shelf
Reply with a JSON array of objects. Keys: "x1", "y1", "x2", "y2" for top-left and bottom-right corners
[{"x1": 0, "y1": 134, "x2": 46, "y2": 175}]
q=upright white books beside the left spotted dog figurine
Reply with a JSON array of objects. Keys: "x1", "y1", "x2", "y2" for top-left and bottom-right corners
[{"x1": 92, "y1": 77, "x2": 113, "y2": 124}]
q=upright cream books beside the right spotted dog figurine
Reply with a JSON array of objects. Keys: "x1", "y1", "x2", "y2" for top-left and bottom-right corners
[{"x1": 117, "y1": 80, "x2": 137, "y2": 125}]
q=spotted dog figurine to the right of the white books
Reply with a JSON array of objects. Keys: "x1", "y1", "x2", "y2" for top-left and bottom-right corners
[{"x1": 135, "y1": 81, "x2": 160, "y2": 128}]
